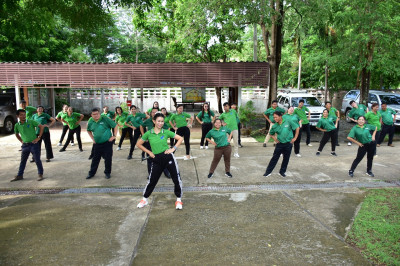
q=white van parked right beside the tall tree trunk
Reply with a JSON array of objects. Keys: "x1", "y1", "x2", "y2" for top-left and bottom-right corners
[{"x1": 277, "y1": 90, "x2": 325, "y2": 126}]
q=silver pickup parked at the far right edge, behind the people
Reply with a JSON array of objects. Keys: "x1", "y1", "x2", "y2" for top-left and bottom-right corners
[{"x1": 341, "y1": 90, "x2": 400, "y2": 126}]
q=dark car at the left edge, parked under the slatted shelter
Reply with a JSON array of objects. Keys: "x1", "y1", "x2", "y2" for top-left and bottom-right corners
[{"x1": 0, "y1": 92, "x2": 17, "y2": 134}]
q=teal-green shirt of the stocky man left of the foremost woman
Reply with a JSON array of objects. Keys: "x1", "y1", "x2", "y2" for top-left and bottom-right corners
[{"x1": 87, "y1": 116, "x2": 117, "y2": 144}]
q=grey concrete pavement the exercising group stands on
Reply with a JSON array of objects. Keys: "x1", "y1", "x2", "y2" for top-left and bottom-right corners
[{"x1": 0, "y1": 126, "x2": 400, "y2": 265}]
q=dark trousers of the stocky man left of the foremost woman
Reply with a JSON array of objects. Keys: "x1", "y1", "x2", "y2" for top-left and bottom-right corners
[{"x1": 89, "y1": 141, "x2": 113, "y2": 176}]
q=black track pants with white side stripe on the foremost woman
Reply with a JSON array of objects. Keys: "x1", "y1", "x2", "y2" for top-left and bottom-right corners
[{"x1": 143, "y1": 153, "x2": 182, "y2": 198}]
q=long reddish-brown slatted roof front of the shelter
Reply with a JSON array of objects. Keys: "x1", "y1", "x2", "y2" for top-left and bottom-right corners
[{"x1": 0, "y1": 62, "x2": 269, "y2": 88}]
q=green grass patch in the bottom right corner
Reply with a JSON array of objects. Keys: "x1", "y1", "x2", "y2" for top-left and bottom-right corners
[{"x1": 347, "y1": 188, "x2": 400, "y2": 265}]
